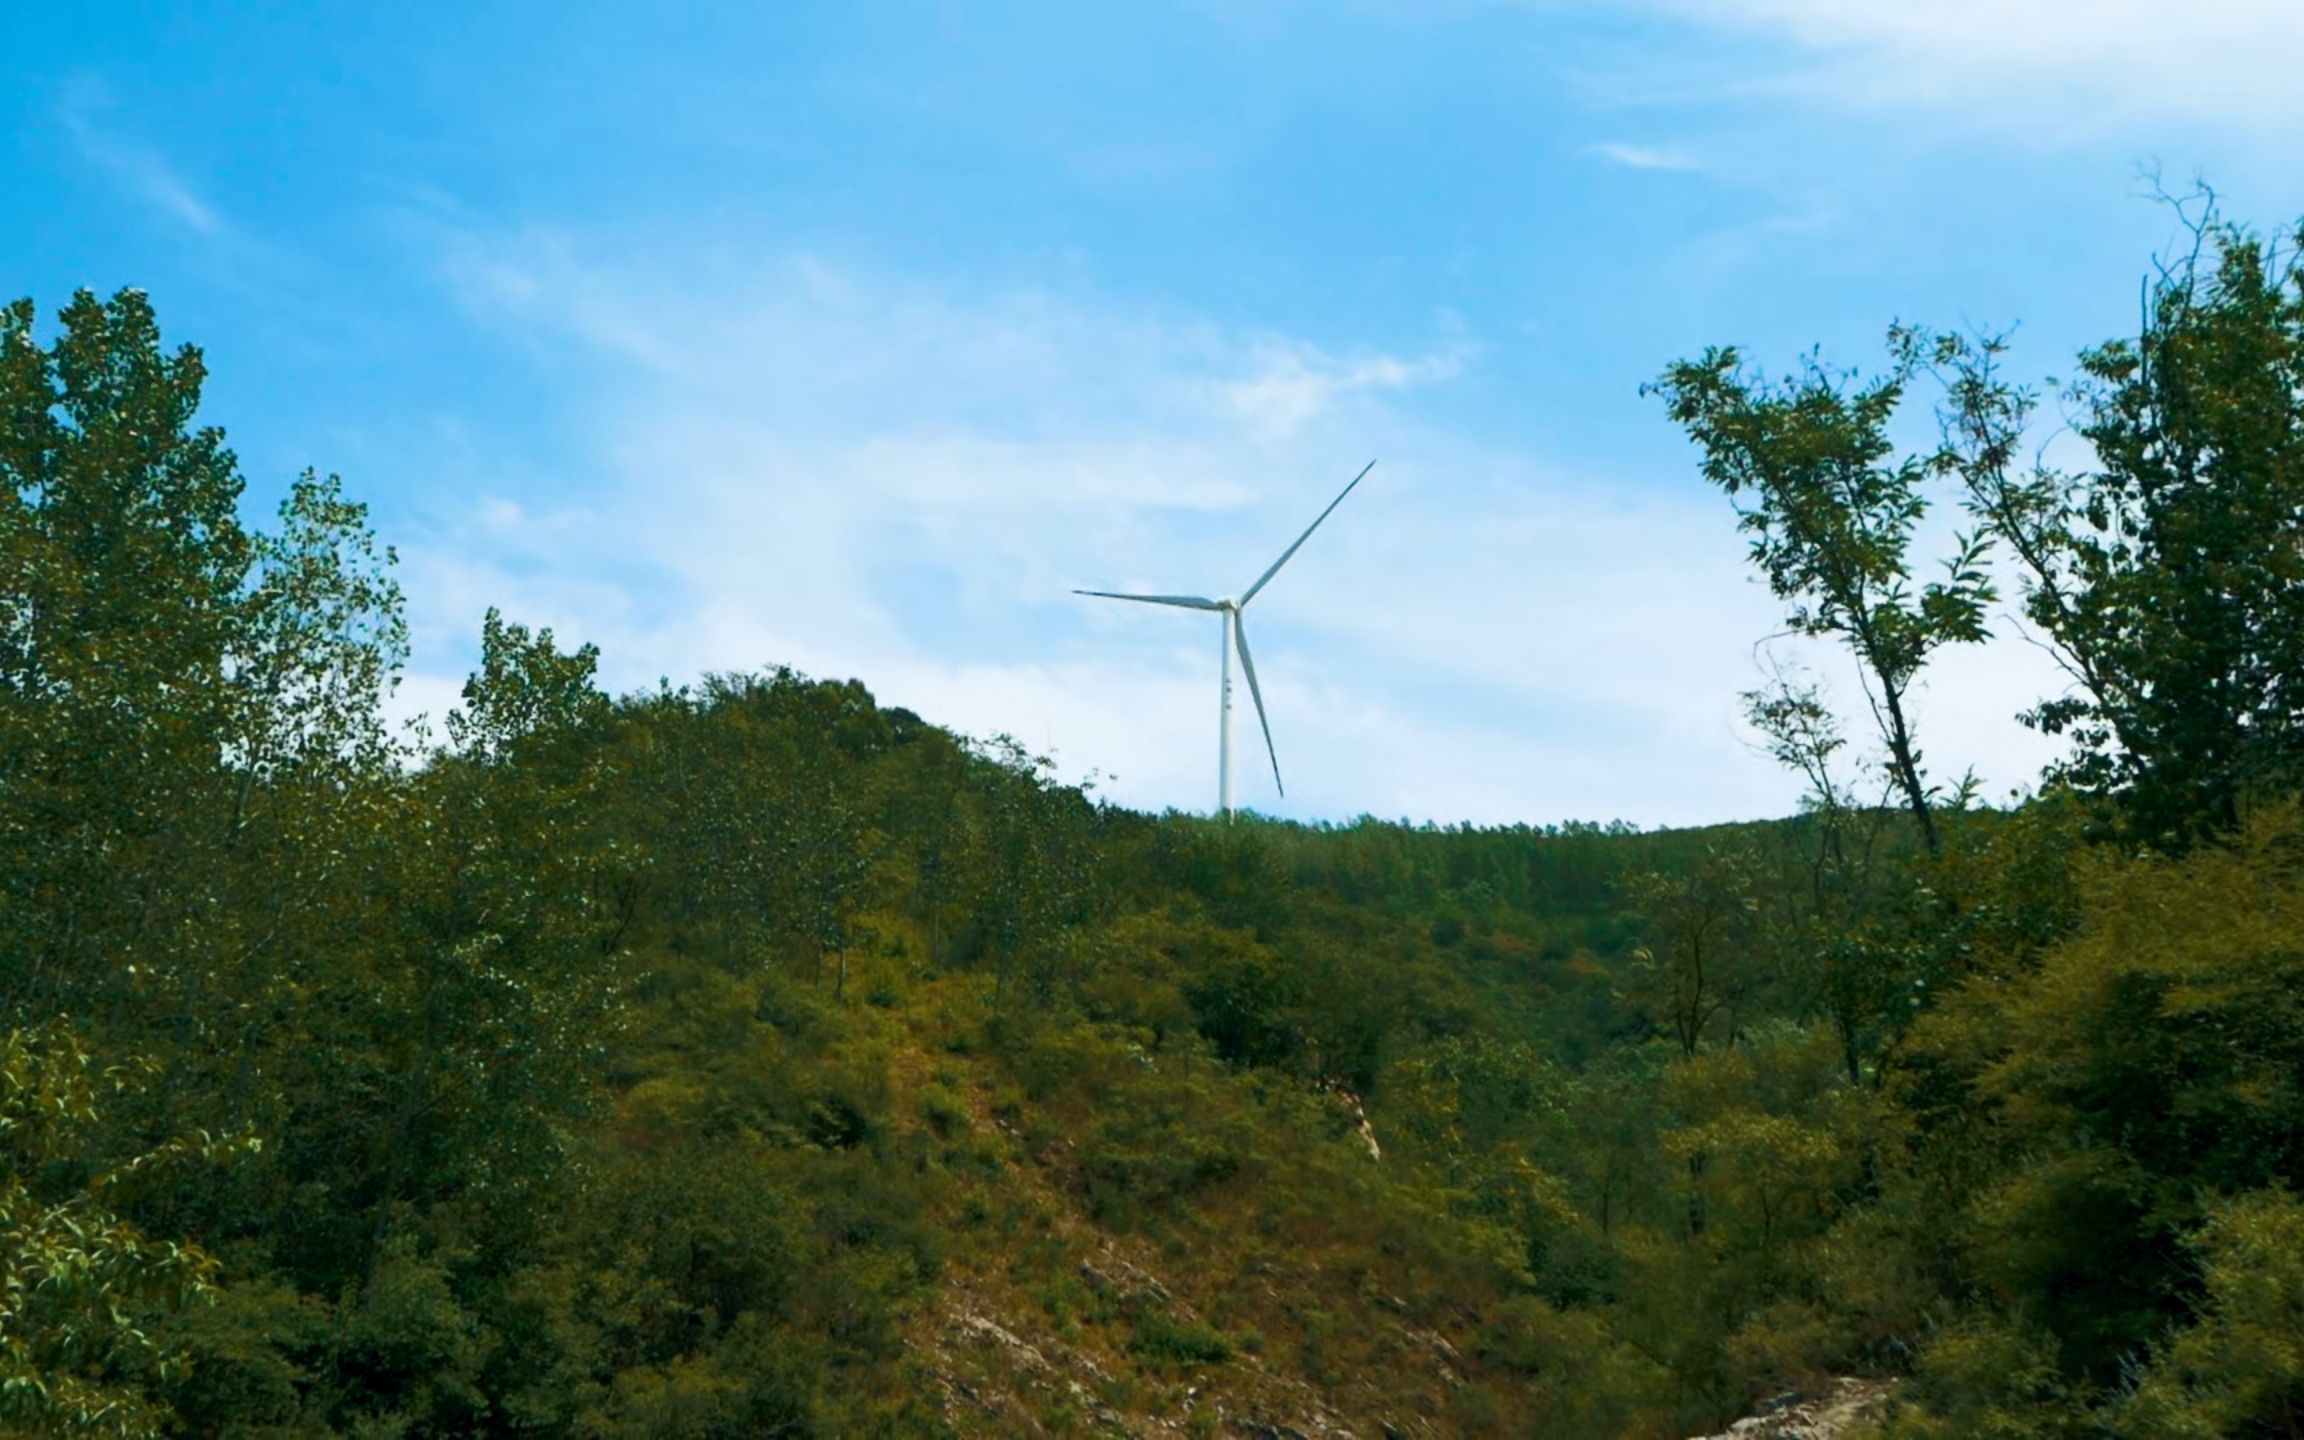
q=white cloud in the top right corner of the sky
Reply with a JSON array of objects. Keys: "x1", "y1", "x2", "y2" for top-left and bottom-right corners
[{"x1": 1659, "y1": 0, "x2": 2304, "y2": 131}]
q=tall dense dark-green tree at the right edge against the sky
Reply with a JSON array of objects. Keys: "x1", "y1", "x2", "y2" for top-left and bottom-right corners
[{"x1": 1933, "y1": 194, "x2": 2304, "y2": 848}]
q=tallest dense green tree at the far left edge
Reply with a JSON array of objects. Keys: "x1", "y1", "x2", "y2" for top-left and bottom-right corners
[{"x1": 0, "y1": 290, "x2": 251, "y2": 1007}]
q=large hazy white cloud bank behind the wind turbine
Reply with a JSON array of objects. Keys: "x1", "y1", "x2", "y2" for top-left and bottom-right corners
[{"x1": 403, "y1": 235, "x2": 2073, "y2": 823}]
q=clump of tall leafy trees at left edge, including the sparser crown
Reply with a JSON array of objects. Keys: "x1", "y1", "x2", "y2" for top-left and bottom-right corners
[{"x1": 0, "y1": 290, "x2": 406, "y2": 1021}]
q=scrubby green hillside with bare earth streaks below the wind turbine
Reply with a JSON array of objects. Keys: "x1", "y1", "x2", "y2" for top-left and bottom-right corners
[{"x1": 0, "y1": 620, "x2": 2082, "y2": 1435}]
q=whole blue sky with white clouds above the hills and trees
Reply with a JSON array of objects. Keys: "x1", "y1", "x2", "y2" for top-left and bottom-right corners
[{"x1": 0, "y1": 0, "x2": 2304, "y2": 825}]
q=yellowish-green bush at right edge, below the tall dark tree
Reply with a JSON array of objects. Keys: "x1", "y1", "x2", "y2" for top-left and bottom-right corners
[{"x1": 1922, "y1": 813, "x2": 2304, "y2": 1380}]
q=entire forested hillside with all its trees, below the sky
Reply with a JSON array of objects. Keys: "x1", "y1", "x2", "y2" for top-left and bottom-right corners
[{"x1": 13, "y1": 196, "x2": 2304, "y2": 1438}]
